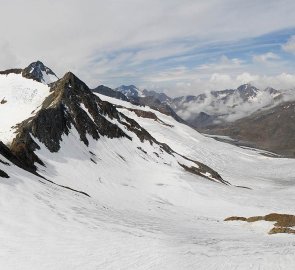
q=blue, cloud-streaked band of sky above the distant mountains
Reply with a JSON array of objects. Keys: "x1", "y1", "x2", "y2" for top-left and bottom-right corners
[{"x1": 88, "y1": 28, "x2": 295, "y2": 95}]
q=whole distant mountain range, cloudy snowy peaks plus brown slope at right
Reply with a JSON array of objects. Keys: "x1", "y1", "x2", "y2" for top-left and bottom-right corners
[{"x1": 93, "y1": 84, "x2": 295, "y2": 156}]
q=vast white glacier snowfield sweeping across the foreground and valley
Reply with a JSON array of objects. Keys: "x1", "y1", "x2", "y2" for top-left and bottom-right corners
[{"x1": 0, "y1": 92, "x2": 295, "y2": 270}]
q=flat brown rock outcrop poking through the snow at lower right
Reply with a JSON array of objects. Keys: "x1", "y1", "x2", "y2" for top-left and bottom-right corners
[{"x1": 224, "y1": 213, "x2": 295, "y2": 234}]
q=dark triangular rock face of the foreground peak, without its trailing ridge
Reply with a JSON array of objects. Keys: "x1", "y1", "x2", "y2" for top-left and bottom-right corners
[{"x1": 11, "y1": 72, "x2": 128, "y2": 168}]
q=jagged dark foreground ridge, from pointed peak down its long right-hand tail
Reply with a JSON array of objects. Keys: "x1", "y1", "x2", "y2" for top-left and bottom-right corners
[{"x1": 0, "y1": 62, "x2": 227, "y2": 187}]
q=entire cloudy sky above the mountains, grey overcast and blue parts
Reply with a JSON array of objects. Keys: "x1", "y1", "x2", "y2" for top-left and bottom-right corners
[{"x1": 0, "y1": 0, "x2": 295, "y2": 96}]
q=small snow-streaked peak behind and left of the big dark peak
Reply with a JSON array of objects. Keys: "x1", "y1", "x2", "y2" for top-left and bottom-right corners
[{"x1": 22, "y1": 61, "x2": 58, "y2": 84}]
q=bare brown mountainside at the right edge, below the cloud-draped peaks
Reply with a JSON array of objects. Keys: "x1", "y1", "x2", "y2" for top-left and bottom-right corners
[{"x1": 204, "y1": 101, "x2": 295, "y2": 157}]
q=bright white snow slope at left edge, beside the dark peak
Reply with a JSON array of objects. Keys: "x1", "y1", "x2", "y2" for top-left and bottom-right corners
[{"x1": 0, "y1": 74, "x2": 50, "y2": 143}]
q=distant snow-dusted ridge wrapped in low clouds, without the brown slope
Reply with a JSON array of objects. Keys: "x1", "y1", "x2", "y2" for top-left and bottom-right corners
[{"x1": 110, "y1": 83, "x2": 289, "y2": 129}]
